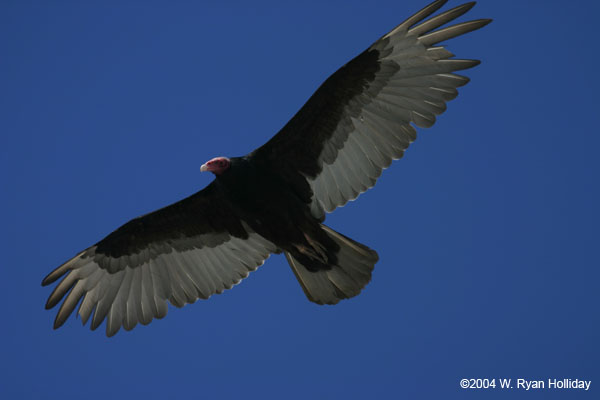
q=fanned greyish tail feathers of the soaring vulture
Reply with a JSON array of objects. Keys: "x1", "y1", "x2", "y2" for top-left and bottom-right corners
[{"x1": 285, "y1": 225, "x2": 379, "y2": 304}]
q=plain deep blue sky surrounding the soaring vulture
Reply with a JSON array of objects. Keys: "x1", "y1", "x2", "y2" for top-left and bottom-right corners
[{"x1": 0, "y1": 0, "x2": 600, "y2": 399}]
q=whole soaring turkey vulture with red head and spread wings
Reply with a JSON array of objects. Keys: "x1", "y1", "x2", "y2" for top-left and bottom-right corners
[{"x1": 42, "y1": 0, "x2": 491, "y2": 336}]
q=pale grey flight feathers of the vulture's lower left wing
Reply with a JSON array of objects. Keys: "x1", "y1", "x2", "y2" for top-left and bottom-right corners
[{"x1": 46, "y1": 227, "x2": 276, "y2": 336}]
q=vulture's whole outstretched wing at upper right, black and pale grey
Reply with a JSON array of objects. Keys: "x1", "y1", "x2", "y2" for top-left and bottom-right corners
[{"x1": 253, "y1": 0, "x2": 491, "y2": 219}]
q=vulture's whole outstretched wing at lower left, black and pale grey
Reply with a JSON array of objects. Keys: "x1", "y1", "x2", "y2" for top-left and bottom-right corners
[{"x1": 42, "y1": 182, "x2": 276, "y2": 336}]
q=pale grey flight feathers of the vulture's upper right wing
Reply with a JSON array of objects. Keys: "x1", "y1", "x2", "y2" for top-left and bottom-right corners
[{"x1": 307, "y1": 1, "x2": 489, "y2": 218}]
